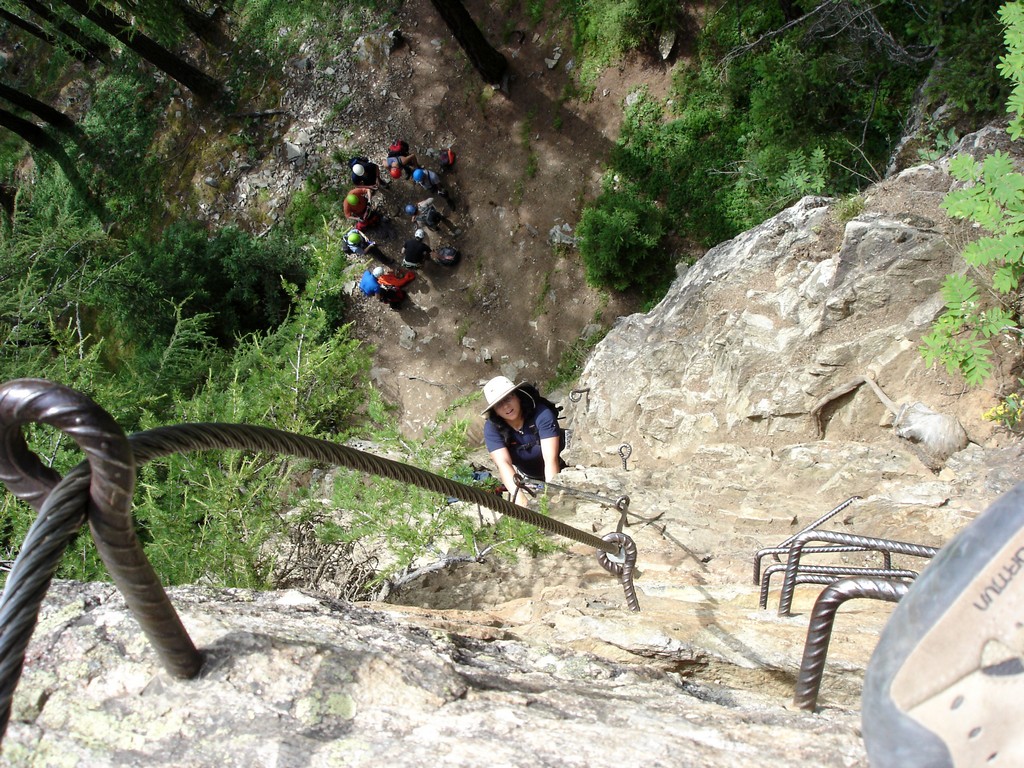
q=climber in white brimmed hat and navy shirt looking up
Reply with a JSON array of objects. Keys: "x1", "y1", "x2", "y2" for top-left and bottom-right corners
[{"x1": 480, "y1": 376, "x2": 565, "y2": 506}]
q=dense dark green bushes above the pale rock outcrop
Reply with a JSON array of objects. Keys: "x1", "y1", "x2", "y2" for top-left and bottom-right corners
[{"x1": 573, "y1": 0, "x2": 1011, "y2": 307}]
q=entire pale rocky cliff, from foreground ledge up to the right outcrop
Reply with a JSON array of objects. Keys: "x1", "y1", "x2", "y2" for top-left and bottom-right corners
[{"x1": 2, "y1": 130, "x2": 1024, "y2": 768}]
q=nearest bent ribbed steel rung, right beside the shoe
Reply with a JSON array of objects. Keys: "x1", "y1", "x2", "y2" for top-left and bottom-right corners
[{"x1": 793, "y1": 577, "x2": 910, "y2": 711}]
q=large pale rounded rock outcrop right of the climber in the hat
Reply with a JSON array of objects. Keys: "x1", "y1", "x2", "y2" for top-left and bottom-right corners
[{"x1": 569, "y1": 123, "x2": 1014, "y2": 473}]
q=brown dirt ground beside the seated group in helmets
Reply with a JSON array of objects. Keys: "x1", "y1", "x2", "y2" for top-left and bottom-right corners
[{"x1": 339, "y1": 0, "x2": 684, "y2": 439}]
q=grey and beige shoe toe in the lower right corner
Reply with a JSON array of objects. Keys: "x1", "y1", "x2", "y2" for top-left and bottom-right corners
[{"x1": 861, "y1": 484, "x2": 1024, "y2": 768}]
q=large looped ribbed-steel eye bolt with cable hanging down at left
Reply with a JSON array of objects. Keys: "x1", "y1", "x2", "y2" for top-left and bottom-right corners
[{"x1": 0, "y1": 379, "x2": 202, "y2": 741}]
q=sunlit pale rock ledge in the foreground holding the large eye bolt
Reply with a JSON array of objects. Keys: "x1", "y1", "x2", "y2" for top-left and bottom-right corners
[{"x1": 4, "y1": 584, "x2": 857, "y2": 768}]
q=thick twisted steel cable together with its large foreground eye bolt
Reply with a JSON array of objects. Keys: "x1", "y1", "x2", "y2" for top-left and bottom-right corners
[{"x1": 0, "y1": 379, "x2": 639, "y2": 738}]
